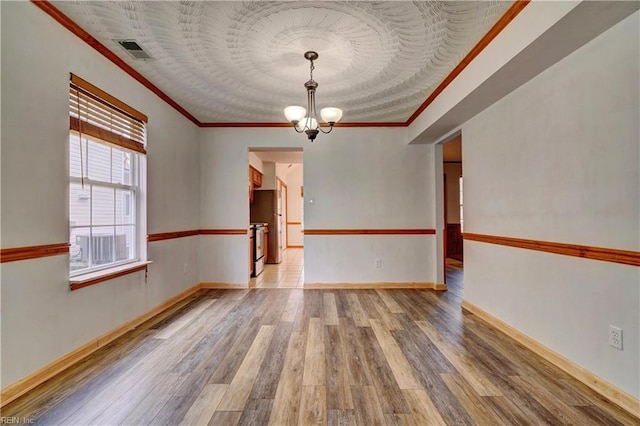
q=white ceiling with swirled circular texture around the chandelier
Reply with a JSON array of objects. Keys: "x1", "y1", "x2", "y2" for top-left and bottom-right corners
[{"x1": 53, "y1": 1, "x2": 512, "y2": 123}]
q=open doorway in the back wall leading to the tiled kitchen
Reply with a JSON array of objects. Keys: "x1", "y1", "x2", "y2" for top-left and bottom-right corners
[{"x1": 249, "y1": 148, "x2": 304, "y2": 288}]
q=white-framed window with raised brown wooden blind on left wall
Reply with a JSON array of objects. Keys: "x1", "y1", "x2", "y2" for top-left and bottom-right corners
[{"x1": 69, "y1": 75, "x2": 146, "y2": 276}]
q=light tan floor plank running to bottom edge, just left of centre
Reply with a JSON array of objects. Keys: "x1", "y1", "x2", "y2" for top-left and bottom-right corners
[{"x1": 269, "y1": 332, "x2": 305, "y2": 426}]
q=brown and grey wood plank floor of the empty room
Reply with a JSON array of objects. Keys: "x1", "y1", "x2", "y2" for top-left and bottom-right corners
[{"x1": 2, "y1": 264, "x2": 639, "y2": 425}]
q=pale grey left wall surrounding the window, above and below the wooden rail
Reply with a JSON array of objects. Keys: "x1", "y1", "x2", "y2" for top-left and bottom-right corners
[{"x1": 0, "y1": 2, "x2": 200, "y2": 388}]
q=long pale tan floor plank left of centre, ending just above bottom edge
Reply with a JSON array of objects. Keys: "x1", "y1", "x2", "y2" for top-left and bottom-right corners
[{"x1": 218, "y1": 325, "x2": 275, "y2": 411}]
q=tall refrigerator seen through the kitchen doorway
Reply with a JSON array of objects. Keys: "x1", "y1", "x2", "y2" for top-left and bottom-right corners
[{"x1": 250, "y1": 189, "x2": 282, "y2": 263}]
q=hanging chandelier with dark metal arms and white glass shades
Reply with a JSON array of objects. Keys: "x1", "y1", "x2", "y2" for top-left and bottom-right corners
[{"x1": 284, "y1": 51, "x2": 342, "y2": 142}]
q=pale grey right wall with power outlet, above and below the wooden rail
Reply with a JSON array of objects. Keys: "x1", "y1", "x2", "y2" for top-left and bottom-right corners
[{"x1": 462, "y1": 12, "x2": 640, "y2": 398}]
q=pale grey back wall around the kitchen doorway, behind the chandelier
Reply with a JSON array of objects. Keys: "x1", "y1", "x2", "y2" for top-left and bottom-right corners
[{"x1": 201, "y1": 128, "x2": 436, "y2": 283}]
